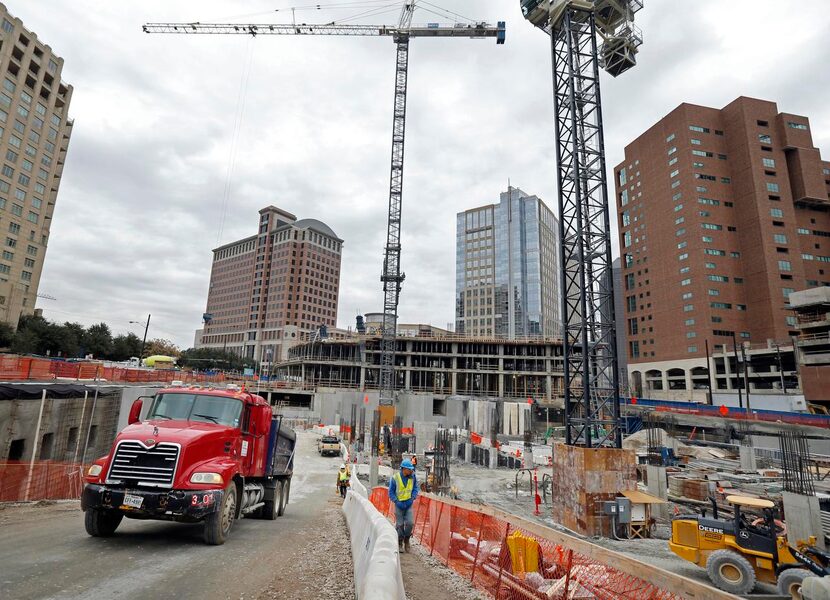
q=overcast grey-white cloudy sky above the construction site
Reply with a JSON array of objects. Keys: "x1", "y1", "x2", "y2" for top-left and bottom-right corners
[{"x1": 14, "y1": 0, "x2": 830, "y2": 347}]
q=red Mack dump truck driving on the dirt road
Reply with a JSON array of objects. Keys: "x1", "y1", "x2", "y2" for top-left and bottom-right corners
[{"x1": 81, "y1": 387, "x2": 296, "y2": 544}]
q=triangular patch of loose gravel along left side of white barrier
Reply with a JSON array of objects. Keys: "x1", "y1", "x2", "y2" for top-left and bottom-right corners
[{"x1": 259, "y1": 496, "x2": 355, "y2": 600}]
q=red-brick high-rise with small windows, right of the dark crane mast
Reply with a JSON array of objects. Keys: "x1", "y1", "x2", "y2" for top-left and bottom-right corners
[{"x1": 615, "y1": 97, "x2": 830, "y2": 390}]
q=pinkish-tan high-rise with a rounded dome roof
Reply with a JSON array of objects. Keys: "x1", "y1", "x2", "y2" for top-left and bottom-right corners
[{"x1": 197, "y1": 206, "x2": 343, "y2": 362}]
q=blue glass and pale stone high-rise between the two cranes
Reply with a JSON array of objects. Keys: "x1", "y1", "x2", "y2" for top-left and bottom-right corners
[{"x1": 455, "y1": 187, "x2": 561, "y2": 339}]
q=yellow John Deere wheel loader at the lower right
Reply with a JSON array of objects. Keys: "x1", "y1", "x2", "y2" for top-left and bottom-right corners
[{"x1": 669, "y1": 496, "x2": 830, "y2": 600}]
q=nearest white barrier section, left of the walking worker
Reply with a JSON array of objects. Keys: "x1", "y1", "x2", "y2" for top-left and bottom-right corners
[{"x1": 343, "y1": 484, "x2": 406, "y2": 600}]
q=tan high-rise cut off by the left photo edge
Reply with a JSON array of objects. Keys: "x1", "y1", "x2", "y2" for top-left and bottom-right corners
[{"x1": 0, "y1": 4, "x2": 72, "y2": 327}]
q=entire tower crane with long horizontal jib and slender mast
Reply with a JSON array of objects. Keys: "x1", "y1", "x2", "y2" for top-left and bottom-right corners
[{"x1": 143, "y1": 0, "x2": 506, "y2": 406}]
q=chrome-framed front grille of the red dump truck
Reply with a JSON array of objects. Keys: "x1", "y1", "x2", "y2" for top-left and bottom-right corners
[{"x1": 107, "y1": 440, "x2": 179, "y2": 488}]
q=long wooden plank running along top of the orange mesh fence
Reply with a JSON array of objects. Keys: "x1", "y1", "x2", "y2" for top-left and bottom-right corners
[{"x1": 424, "y1": 494, "x2": 737, "y2": 600}]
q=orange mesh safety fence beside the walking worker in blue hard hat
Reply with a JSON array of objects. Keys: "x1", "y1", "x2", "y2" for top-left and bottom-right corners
[{"x1": 370, "y1": 487, "x2": 681, "y2": 600}]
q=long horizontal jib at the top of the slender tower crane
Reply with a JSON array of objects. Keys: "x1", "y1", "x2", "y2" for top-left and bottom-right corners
[{"x1": 142, "y1": 21, "x2": 507, "y2": 44}]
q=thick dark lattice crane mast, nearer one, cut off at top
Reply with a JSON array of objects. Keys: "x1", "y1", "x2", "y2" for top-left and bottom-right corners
[{"x1": 520, "y1": 0, "x2": 643, "y2": 448}]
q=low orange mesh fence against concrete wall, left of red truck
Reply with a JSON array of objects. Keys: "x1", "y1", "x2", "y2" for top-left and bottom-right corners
[{"x1": 0, "y1": 461, "x2": 84, "y2": 502}]
